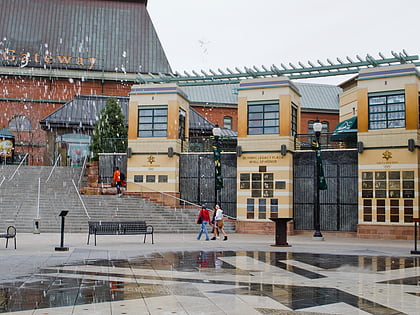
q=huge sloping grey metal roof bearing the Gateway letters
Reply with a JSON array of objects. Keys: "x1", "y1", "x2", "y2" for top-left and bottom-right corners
[{"x1": 0, "y1": 0, "x2": 171, "y2": 73}]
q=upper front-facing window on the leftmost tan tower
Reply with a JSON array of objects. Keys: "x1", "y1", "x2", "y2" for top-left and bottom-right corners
[{"x1": 138, "y1": 106, "x2": 168, "y2": 138}]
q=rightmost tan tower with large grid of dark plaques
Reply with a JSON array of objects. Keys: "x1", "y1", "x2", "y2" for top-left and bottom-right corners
[{"x1": 340, "y1": 65, "x2": 420, "y2": 239}]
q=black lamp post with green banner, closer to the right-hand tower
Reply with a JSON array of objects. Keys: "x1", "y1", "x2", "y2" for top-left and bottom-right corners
[{"x1": 312, "y1": 119, "x2": 326, "y2": 241}]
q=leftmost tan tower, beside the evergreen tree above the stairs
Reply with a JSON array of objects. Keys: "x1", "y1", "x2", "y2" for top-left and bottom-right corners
[{"x1": 127, "y1": 84, "x2": 189, "y2": 202}]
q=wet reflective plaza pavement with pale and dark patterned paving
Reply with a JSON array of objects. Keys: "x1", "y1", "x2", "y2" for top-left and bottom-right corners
[{"x1": 0, "y1": 233, "x2": 420, "y2": 314}]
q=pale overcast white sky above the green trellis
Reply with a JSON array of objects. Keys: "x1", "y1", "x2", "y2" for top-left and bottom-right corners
[{"x1": 147, "y1": 0, "x2": 420, "y2": 84}]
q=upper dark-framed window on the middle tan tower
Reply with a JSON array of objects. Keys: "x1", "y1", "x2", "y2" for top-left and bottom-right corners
[{"x1": 248, "y1": 101, "x2": 279, "y2": 135}]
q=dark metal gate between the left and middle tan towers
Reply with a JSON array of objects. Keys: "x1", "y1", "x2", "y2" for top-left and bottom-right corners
[{"x1": 179, "y1": 153, "x2": 236, "y2": 217}]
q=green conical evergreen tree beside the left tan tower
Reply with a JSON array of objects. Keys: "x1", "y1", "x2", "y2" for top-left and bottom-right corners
[{"x1": 90, "y1": 97, "x2": 128, "y2": 161}]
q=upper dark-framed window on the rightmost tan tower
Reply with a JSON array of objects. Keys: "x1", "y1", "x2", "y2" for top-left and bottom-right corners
[{"x1": 369, "y1": 92, "x2": 405, "y2": 129}]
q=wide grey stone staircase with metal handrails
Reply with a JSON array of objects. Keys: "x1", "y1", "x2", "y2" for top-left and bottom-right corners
[{"x1": 0, "y1": 165, "x2": 234, "y2": 233}]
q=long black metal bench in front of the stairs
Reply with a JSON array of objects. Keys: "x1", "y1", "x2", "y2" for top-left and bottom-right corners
[{"x1": 87, "y1": 221, "x2": 154, "y2": 246}]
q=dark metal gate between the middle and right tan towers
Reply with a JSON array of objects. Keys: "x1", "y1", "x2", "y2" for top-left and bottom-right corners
[{"x1": 293, "y1": 150, "x2": 358, "y2": 232}]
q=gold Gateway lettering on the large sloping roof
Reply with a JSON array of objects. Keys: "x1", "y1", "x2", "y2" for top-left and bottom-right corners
[{"x1": 0, "y1": 49, "x2": 98, "y2": 70}]
